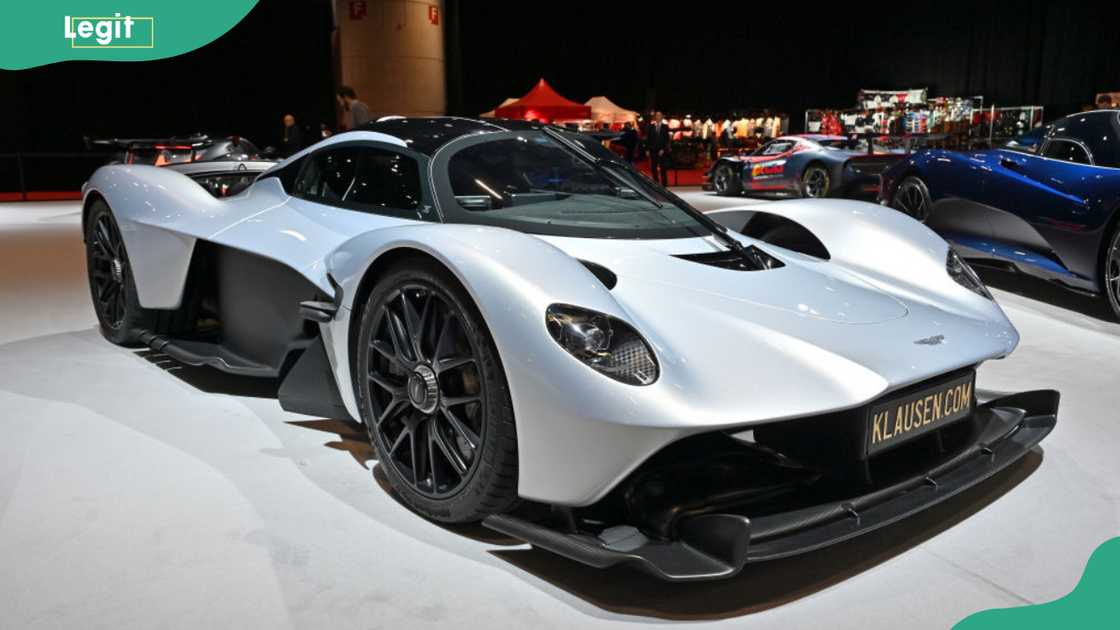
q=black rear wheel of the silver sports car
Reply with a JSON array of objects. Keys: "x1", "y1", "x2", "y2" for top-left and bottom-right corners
[{"x1": 85, "y1": 200, "x2": 153, "y2": 345}]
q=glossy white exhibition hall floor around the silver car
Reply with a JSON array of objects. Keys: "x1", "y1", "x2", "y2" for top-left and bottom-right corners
[{"x1": 0, "y1": 191, "x2": 1120, "y2": 630}]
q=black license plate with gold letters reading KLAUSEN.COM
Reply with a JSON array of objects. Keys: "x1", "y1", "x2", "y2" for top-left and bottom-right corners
[{"x1": 867, "y1": 372, "x2": 976, "y2": 455}]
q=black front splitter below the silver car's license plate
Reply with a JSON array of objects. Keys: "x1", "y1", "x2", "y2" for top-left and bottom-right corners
[{"x1": 483, "y1": 390, "x2": 1060, "y2": 582}]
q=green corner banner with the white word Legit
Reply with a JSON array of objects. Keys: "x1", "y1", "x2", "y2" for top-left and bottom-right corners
[{"x1": 0, "y1": 0, "x2": 256, "y2": 70}]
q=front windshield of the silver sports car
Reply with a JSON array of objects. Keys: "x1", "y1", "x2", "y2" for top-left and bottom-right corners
[{"x1": 436, "y1": 130, "x2": 710, "y2": 239}]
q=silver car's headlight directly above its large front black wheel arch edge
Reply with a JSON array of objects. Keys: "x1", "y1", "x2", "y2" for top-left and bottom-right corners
[{"x1": 544, "y1": 304, "x2": 659, "y2": 385}]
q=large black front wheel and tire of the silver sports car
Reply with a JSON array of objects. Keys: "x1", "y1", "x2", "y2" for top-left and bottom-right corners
[{"x1": 355, "y1": 260, "x2": 517, "y2": 522}]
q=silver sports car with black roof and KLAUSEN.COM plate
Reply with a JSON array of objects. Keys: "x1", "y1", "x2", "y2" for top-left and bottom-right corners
[{"x1": 83, "y1": 118, "x2": 1058, "y2": 580}]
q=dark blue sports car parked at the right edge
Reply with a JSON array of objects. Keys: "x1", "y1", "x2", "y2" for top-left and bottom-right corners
[{"x1": 879, "y1": 110, "x2": 1120, "y2": 317}]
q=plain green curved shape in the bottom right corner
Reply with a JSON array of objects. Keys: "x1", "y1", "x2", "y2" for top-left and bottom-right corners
[{"x1": 953, "y1": 538, "x2": 1120, "y2": 630}]
